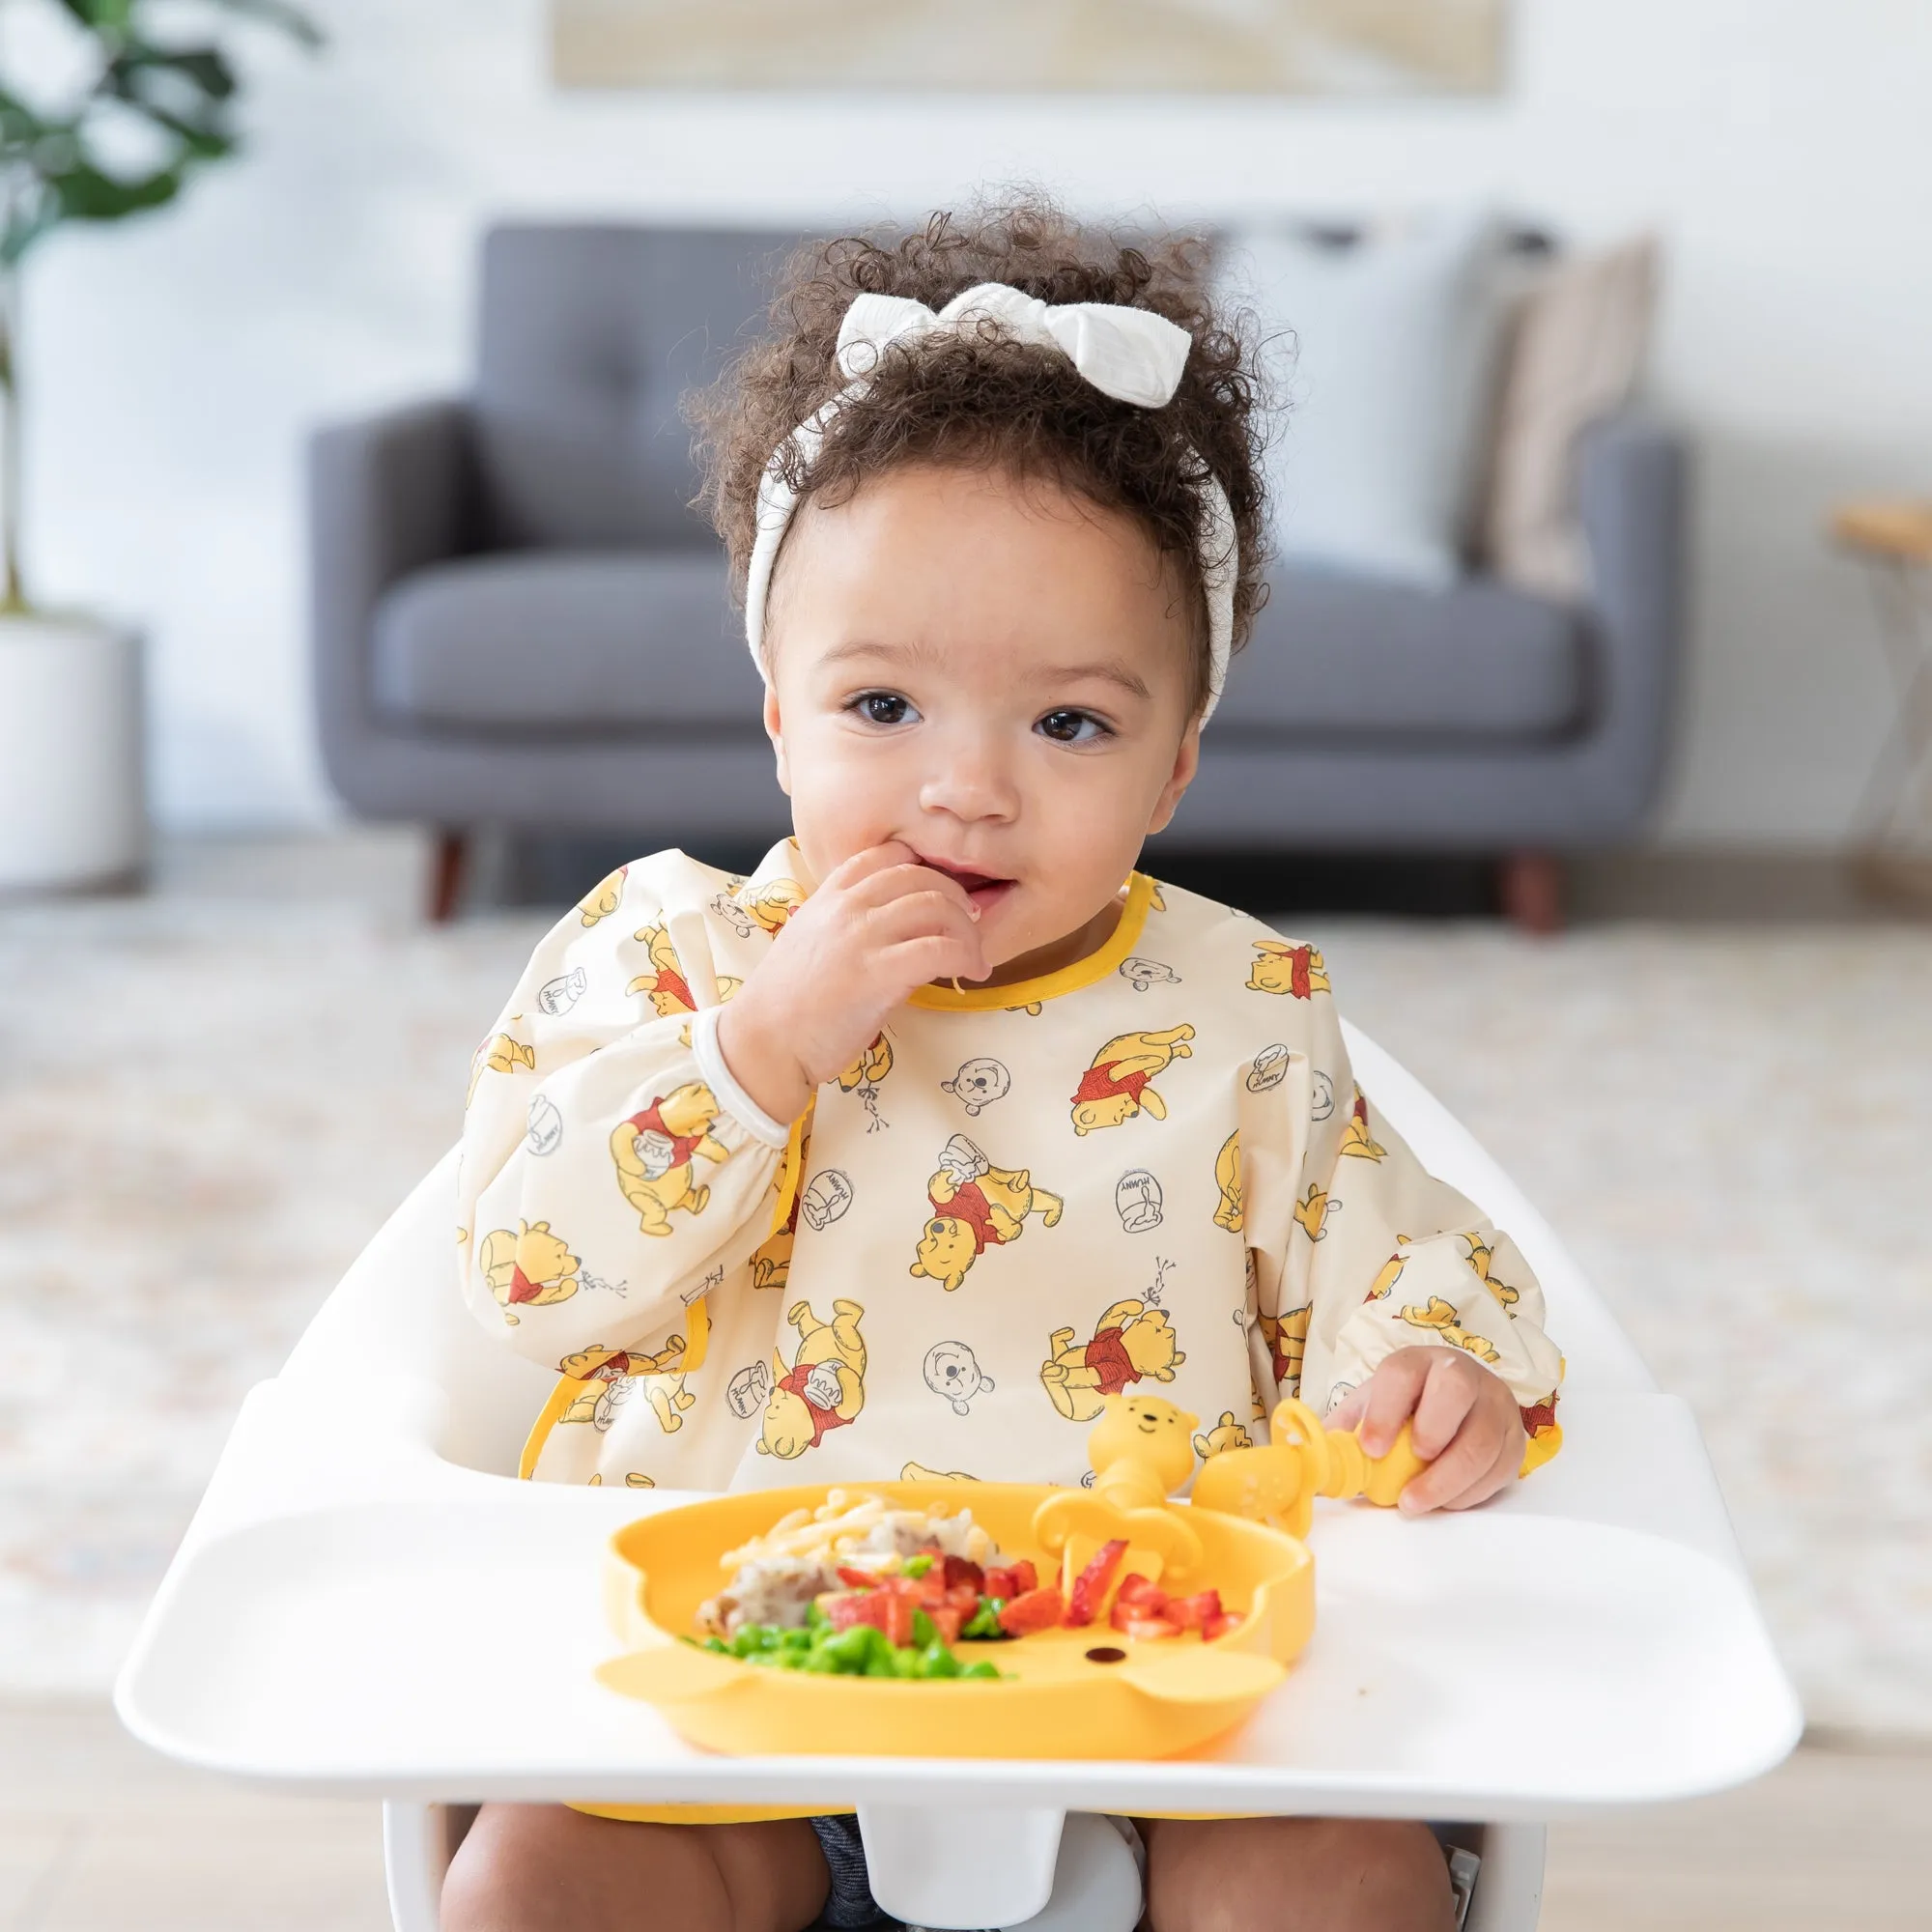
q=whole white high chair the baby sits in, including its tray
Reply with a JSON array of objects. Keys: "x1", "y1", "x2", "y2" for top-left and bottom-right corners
[{"x1": 114, "y1": 1030, "x2": 1801, "y2": 1932}]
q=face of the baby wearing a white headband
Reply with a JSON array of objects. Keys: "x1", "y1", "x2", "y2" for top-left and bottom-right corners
[{"x1": 765, "y1": 466, "x2": 1198, "y2": 968}]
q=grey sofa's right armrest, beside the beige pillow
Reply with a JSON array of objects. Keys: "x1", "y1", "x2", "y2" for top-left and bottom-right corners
[{"x1": 1577, "y1": 412, "x2": 1689, "y2": 831}]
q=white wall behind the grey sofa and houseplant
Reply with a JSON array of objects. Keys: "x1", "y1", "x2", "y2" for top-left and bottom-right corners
[{"x1": 14, "y1": 0, "x2": 1932, "y2": 842}]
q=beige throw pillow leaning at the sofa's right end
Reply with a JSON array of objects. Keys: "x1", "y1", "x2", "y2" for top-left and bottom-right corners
[{"x1": 1484, "y1": 236, "x2": 1658, "y2": 601}]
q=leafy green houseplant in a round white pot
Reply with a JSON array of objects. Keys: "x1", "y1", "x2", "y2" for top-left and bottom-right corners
[{"x1": 0, "y1": 0, "x2": 321, "y2": 891}]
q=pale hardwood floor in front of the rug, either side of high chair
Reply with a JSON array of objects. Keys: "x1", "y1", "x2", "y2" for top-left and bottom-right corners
[{"x1": 0, "y1": 1704, "x2": 1932, "y2": 1932}]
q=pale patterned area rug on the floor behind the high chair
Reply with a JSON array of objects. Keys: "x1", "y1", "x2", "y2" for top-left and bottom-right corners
[{"x1": 0, "y1": 896, "x2": 1932, "y2": 1735}]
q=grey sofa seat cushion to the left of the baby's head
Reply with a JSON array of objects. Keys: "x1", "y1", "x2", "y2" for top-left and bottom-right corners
[{"x1": 371, "y1": 551, "x2": 763, "y2": 738}]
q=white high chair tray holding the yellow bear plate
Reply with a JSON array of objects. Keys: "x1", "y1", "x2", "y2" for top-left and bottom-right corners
[{"x1": 118, "y1": 1383, "x2": 1799, "y2": 1820}]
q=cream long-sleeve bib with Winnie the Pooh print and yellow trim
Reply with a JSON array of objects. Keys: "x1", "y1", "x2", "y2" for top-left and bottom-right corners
[{"x1": 458, "y1": 840, "x2": 1563, "y2": 1490}]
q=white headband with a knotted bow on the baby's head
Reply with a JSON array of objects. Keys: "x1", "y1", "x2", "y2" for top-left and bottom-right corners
[{"x1": 744, "y1": 282, "x2": 1240, "y2": 724}]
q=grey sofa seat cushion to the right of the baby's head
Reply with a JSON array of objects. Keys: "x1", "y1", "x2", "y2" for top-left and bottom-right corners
[{"x1": 1208, "y1": 570, "x2": 1590, "y2": 742}]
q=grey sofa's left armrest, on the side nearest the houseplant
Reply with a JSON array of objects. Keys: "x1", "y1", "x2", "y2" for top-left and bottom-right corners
[{"x1": 309, "y1": 400, "x2": 475, "y2": 804}]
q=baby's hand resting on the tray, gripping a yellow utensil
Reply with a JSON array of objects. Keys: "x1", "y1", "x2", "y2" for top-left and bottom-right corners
[{"x1": 1327, "y1": 1347, "x2": 1528, "y2": 1515}]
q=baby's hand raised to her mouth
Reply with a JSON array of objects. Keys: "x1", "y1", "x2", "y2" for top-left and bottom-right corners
[{"x1": 719, "y1": 840, "x2": 987, "y2": 1121}]
